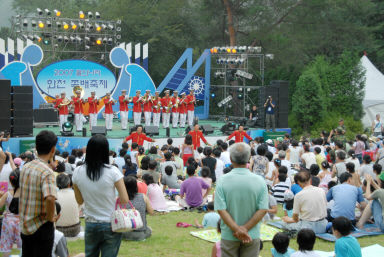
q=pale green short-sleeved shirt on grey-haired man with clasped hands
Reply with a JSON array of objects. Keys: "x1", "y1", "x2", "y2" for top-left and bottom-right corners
[{"x1": 215, "y1": 168, "x2": 268, "y2": 241}]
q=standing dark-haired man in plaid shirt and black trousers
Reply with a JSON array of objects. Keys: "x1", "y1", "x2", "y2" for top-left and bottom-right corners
[{"x1": 19, "y1": 130, "x2": 57, "y2": 257}]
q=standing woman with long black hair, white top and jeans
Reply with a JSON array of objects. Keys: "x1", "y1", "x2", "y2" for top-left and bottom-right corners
[{"x1": 73, "y1": 135, "x2": 128, "y2": 256}]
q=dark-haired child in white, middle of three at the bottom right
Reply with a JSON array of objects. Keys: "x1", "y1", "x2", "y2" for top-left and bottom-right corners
[{"x1": 291, "y1": 229, "x2": 320, "y2": 257}]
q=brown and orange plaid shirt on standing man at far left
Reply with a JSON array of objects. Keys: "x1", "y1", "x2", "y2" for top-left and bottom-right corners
[{"x1": 19, "y1": 159, "x2": 57, "y2": 235}]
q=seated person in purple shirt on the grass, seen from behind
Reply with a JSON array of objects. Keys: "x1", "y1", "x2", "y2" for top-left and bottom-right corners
[{"x1": 176, "y1": 166, "x2": 211, "y2": 208}]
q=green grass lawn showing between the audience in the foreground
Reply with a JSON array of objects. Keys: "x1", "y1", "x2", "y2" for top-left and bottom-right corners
[{"x1": 68, "y1": 208, "x2": 384, "y2": 257}]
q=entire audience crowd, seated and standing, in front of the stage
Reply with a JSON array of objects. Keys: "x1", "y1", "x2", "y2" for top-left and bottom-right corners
[{"x1": 0, "y1": 123, "x2": 384, "y2": 254}]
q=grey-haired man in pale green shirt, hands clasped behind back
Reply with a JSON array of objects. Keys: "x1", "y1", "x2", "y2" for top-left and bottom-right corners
[{"x1": 215, "y1": 143, "x2": 268, "y2": 257}]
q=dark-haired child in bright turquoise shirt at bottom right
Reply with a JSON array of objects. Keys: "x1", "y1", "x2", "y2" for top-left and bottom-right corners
[{"x1": 332, "y1": 216, "x2": 362, "y2": 257}]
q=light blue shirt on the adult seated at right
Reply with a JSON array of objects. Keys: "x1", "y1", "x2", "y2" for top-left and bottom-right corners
[{"x1": 327, "y1": 183, "x2": 364, "y2": 220}]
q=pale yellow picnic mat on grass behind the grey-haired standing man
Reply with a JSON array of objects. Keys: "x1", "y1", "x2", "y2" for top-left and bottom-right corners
[{"x1": 190, "y1": 224, "x2": 281, "y2": 243}]
